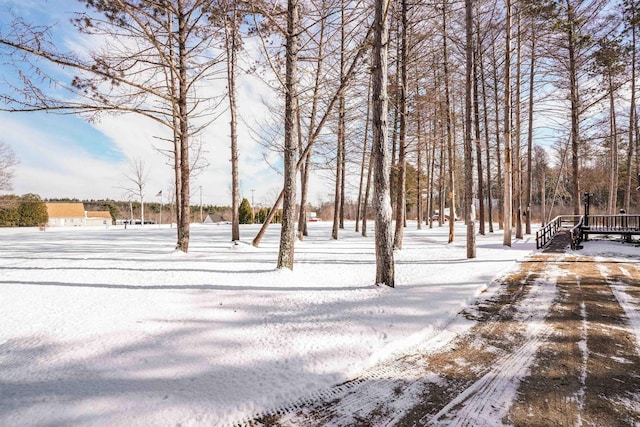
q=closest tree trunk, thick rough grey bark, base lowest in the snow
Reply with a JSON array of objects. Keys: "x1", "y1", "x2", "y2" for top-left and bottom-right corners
[{"x1": 372, "y1": 0, "x2": 395, "y2": 287}]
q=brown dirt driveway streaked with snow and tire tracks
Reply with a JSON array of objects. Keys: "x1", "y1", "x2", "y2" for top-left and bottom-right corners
[{"x1": 252, "y1": 254, "x2": 640, "y2": 426}]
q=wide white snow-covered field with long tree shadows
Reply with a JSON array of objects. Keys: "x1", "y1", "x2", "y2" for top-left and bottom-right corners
[{"x1": 0, "y1": 223, "x2": 535, "y2": 426}]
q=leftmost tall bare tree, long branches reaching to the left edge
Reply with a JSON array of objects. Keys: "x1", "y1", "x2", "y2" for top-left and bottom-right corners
[{"x1": 0, "y1": 0, "x2": 226, "y2": 252}]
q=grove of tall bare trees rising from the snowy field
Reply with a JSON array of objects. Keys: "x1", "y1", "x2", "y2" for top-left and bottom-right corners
[{"x1": 0, "y1": 0, "x2": 640, "y2": 286}]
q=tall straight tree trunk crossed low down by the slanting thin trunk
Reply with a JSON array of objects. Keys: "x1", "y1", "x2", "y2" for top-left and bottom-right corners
[{"x1": 277, "y1": 0, "x2": 299, "y2": 270}]
